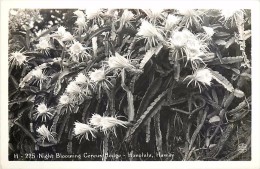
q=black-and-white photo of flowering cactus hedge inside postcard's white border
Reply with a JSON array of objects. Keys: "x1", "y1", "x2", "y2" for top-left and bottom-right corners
[{"x1": 8, "y1": 9, "x2": 251, "y2": 161}]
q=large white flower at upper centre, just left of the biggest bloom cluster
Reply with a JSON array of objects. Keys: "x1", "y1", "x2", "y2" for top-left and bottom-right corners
[{"x1": 137, "y1": 20, "x2": 164, "y2": 47}]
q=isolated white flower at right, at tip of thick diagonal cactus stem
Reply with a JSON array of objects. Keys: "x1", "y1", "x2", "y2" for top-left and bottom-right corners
[{"x1": 184, "y1": 68, "x2": 214, "y2": 91}]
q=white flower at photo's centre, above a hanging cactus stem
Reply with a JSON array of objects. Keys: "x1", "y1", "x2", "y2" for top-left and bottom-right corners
[{"x1": 107, "y1": 52, "x2": 135, "y2": 69}]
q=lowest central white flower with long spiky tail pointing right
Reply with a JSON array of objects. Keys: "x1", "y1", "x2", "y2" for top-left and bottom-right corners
[{"x1": 89, "y1": 114, "x2": 129, "y2": 135}]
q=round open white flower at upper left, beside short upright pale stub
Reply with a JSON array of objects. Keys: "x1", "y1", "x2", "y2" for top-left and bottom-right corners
[{"x1": 69, "y1": 41, "x2": 90, "y2": 62}]
